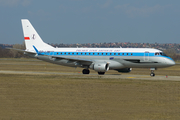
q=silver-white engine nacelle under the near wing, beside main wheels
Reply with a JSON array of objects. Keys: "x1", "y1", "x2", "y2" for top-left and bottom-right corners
[{"x1": 91, "y1": 63, "x2": 109, "y2": 72}]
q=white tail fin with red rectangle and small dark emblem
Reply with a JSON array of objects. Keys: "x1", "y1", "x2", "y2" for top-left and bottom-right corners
[{"x1": 21, "y1": 19, "x2": 54, "y2": 52}]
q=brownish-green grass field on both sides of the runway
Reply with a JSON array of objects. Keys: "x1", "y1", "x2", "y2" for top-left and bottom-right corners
[{"x1": 0, "y1": 59, "x2": 180, "y2": 120}]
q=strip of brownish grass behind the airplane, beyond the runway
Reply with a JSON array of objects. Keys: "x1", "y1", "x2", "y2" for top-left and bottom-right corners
[{"x1": 0, "y1": 58, "x2": 180, "y2": 76}]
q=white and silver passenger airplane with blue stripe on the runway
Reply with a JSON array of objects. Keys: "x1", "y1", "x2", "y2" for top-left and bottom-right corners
[{"x1": 10, "y1": 19, "x2": 175, "y2": 77}]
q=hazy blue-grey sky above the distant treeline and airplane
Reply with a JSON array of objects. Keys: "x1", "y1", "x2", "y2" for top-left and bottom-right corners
[{"x1": 0, "y1": 0, "x2": 180, "y2": 44}]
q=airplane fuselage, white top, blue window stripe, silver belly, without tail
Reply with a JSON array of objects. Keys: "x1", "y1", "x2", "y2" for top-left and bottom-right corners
[{"x1": 34, "y1": 48, "x2": 175, "y2": 69}]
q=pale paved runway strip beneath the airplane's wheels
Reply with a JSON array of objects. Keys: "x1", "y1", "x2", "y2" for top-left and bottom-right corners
[{"x1": 0, "y1": 70, "x2": 180, "y2": 81}]
